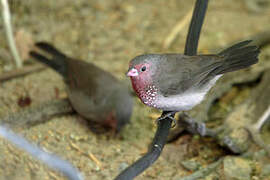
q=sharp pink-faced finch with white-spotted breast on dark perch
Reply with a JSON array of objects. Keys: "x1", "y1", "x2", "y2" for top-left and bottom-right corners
[{"x1": 127, "y1": 41, "x2": 259, "y2": 119}]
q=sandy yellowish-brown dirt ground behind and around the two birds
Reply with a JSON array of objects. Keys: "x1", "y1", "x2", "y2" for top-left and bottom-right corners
[{"x1": 0, "y1": 0, "x2": 270, "y2": 180}]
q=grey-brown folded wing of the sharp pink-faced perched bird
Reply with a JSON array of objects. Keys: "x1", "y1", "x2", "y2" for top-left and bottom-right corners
[{"x1": 154, "y1": 54, "x2": 223, "y2": 97}]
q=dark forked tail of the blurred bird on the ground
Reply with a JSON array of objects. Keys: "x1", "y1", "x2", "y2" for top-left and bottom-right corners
[{"x1": 29, "y1": 42, "x2": 68, "y2": 77}]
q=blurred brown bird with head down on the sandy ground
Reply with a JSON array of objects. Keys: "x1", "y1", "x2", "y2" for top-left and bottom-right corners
[{"x1": 30, "y1": 42, "x2": 133, "y2": 131}]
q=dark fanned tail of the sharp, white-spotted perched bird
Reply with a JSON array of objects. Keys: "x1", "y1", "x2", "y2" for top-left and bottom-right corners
[{"x1": 215, "y1": 40, "x2": 260, "y2": 74}]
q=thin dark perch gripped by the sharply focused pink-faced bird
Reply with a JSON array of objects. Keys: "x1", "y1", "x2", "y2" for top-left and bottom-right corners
[{"x1": 115, "y1": 0, "x2": 208, "y2": 180}]
